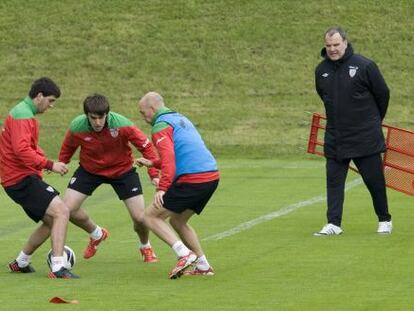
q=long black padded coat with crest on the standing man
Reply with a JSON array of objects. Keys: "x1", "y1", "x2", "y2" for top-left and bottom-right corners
[{"x1": 315, "y1": 43, "x2": 390, "y2": 160}]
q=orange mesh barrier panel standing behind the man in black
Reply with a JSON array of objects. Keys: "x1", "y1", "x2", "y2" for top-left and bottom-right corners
[{"x1": 307, "y1": 113, "x2": 414, "y2": 195}]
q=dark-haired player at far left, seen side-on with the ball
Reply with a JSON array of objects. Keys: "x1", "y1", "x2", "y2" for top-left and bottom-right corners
[{"x1": 0, "y1": 77, "x2": 78, "y2": 278}]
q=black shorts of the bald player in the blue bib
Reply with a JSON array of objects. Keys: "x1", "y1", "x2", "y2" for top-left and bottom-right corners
[{"x1": 163, "y1": 179, "x2": 219, "y2": 214}]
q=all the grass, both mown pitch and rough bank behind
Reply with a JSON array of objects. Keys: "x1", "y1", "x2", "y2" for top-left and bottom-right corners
[{"x1": 0, "y1": 0, "x2": 414, "y2": 311}]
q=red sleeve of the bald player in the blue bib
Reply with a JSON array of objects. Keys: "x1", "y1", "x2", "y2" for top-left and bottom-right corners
[{"x1": 152, "y1": 126, "x2": 175, "y2": 191}]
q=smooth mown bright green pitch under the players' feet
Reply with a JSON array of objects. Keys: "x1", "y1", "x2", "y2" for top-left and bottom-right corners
[{"x1": 0, "y1": 159, "x2": 414, "y2": 310}]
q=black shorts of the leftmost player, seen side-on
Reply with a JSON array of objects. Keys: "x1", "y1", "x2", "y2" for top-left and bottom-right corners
[{"x1": 4, "y1": 175, "x2": 59, "y2": 222}]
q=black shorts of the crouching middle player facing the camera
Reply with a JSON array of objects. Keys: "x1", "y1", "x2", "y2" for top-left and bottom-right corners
[{"x1": 68, "y1": 166, "x2": 142, "y2": 200}]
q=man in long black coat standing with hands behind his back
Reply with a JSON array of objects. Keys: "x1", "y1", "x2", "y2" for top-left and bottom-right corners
[{"x1": 315, "y1": 27, "x2": 392, "y2": 235}]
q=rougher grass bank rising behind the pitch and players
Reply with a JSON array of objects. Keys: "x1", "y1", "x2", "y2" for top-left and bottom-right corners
[{"x1": 0, "y1": 0, "x2": 414, "y2": 158}]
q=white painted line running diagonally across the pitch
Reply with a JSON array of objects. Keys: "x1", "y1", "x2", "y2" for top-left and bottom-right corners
[{"x1": 202, "y1": 178, "x2": 362, "y2": 241}]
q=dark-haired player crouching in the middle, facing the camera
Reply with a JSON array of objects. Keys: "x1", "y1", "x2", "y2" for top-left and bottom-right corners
[{"x1": 59, "y1": 94, "x2": 158, "y2": 262}]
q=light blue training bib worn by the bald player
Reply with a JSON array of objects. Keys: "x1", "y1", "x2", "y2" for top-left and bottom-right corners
[{"x1": 154, "y1": 112, "x2": 217, "y2": 178}]
